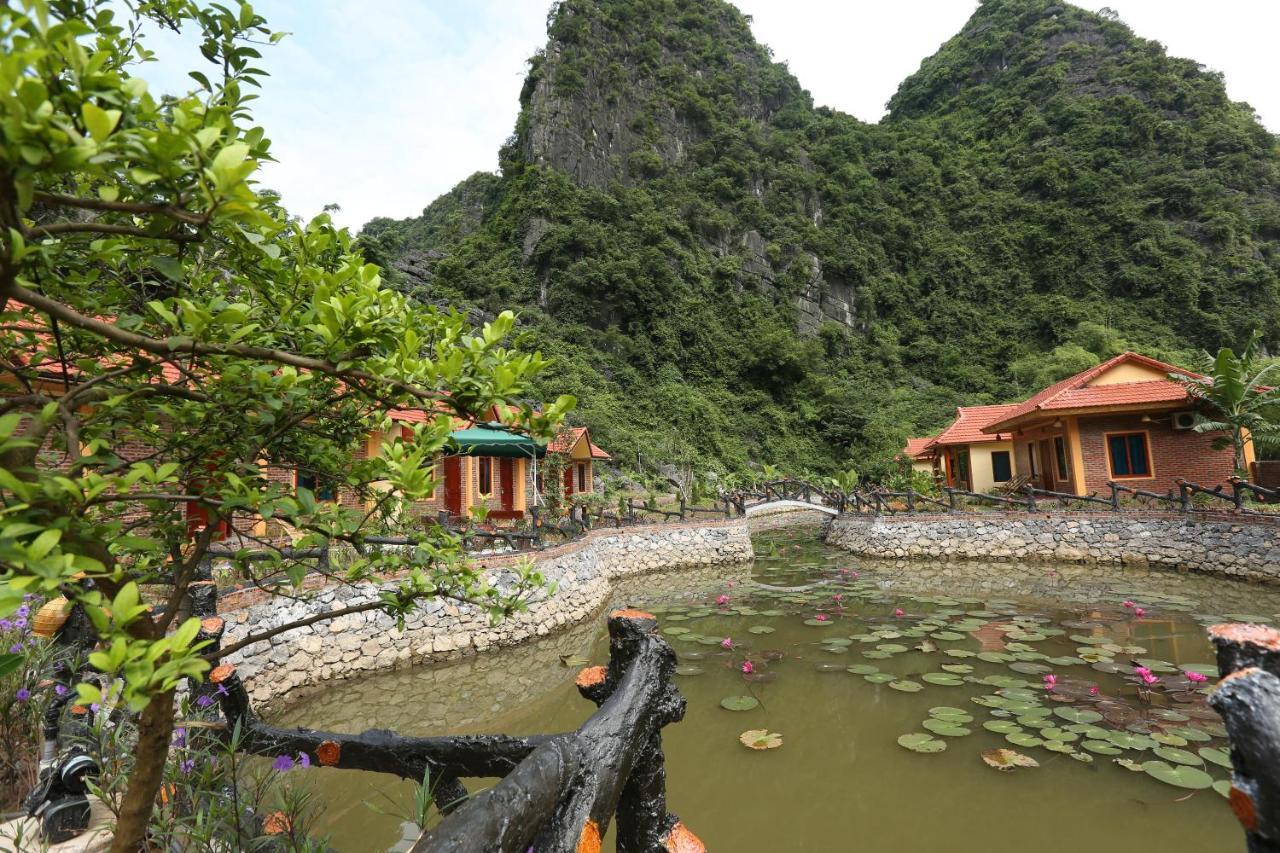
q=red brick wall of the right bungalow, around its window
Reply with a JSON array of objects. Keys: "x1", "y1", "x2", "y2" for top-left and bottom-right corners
[{"x1": 1079, "y1": 415, "x2": 1233, "y2": 493}]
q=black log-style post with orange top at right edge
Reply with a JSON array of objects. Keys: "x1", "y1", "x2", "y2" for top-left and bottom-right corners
[{"x1": 1210, "y1": 624, "x2": 1280, "y2": 853}]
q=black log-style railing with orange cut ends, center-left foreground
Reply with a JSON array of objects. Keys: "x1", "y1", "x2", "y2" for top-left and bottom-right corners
[{"x1": 195, "y1": 610, "x2": 704, "y2": 853}]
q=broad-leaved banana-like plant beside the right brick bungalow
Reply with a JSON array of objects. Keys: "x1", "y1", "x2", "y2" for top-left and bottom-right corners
[{"x1": 1171, "y1": 332, "x2": 1280, "y2": 475}]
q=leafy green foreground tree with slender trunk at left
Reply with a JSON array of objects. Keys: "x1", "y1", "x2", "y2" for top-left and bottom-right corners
[{"x1": 0, "y1": 0, "x2": 573, "y2": 853}]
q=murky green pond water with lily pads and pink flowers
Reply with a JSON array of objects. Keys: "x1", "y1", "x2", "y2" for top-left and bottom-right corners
[{"x1": 275, "y1": 527, "x2": 1280, "y2": 853}]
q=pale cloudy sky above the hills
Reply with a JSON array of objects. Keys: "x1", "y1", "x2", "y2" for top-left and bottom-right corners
[{"x1": 142, "y1": 0, "x2": 1280, "y2": 229}]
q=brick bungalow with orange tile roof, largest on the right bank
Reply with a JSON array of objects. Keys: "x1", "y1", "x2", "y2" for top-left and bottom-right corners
[{"x1": 977, "y1": 352, "x2": 1253, "y2": 494}]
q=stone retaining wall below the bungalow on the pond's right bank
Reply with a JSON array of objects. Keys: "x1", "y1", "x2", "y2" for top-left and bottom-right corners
[{"x1": 827, "y1": 512, "x2": 1280, "y2": 583}]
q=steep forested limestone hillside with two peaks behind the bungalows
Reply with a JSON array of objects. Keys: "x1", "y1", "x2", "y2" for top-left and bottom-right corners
[{"x1": 362, "y1": 0, "x2": 1280, "y2": 479}]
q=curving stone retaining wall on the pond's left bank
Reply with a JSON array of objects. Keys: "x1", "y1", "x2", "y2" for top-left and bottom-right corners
[{"x1": 219, "y1": 519, "x2": 753, "y2": 704}]
